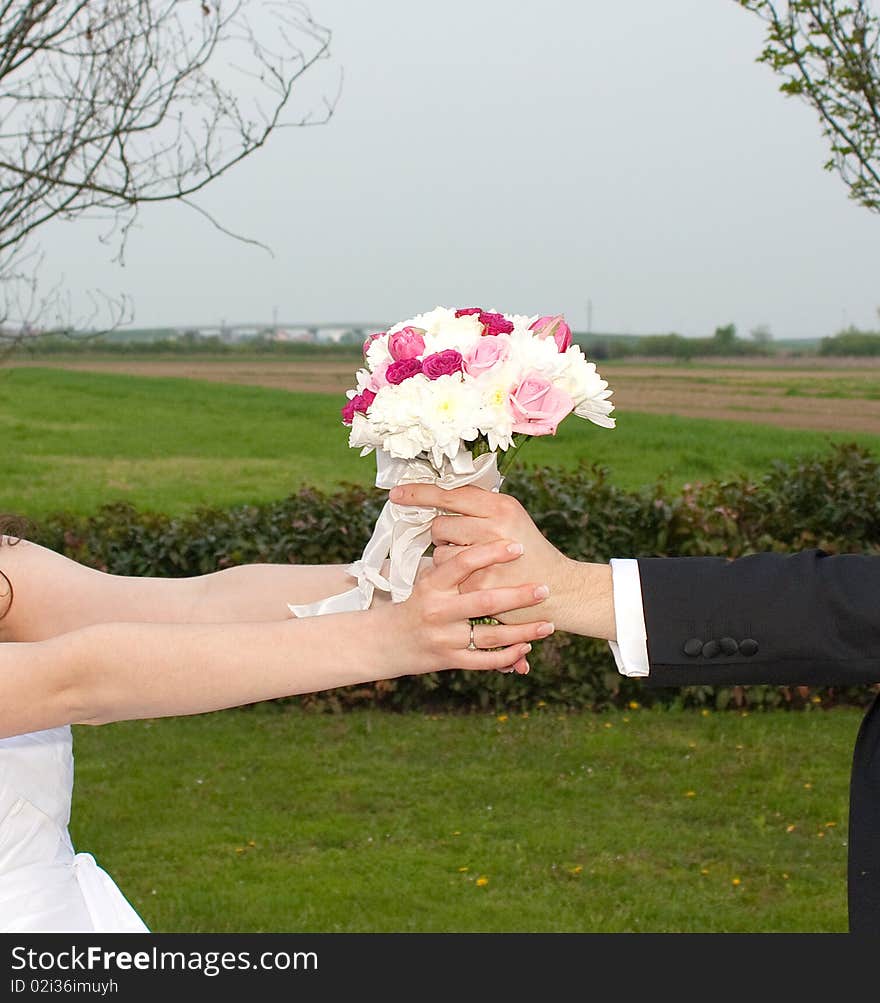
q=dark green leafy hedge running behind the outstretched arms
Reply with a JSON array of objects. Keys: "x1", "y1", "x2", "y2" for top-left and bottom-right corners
[{"x1": 31, "y1": 444, "x2": 880, "y2": 710}]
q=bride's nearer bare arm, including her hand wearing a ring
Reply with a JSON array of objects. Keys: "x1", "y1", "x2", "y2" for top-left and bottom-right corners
[{"x1": 0, "y1": 541, "x2": 553, "y2": 736}]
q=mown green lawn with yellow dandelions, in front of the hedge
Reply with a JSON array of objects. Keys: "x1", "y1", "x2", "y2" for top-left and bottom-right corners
[{"x1": 72, "y1": 706, "x2": 860, "y2": 932}]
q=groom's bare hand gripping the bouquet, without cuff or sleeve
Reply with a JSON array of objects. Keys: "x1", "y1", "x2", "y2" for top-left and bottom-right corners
[{"x1": 391, "y1": 484, "x2": 580, "y2": 623}]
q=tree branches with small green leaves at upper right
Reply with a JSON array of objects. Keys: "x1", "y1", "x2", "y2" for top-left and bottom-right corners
[{"x1": 736, "y1": 0, "x2": 880, "y2": 212}]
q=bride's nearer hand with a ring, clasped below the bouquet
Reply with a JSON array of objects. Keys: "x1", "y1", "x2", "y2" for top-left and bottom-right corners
[{"x1": 388, "y1": 540, "x2": 553, "y2": 674}]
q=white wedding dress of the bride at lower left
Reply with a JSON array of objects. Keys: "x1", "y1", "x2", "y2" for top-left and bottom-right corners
[{"x1": 0, "y1": 726, "x2": 149, "y2": 933}]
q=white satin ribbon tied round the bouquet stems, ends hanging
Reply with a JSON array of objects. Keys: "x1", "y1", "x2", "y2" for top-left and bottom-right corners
[{"x1": 288, "y1": 449, "x2": 503, "y2": 617}]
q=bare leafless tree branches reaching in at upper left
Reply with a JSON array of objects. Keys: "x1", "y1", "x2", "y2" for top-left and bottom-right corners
[{"x1": 0, "y1": 0, "x2": 333, "y2": 355}]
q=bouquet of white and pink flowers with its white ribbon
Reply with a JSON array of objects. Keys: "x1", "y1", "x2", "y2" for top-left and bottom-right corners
[{"x1": 290, "y1": 307, "x2": 614, "y2": 616}]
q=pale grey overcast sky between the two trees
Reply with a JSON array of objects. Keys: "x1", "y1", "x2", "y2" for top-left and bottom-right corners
[{"x1": 37, "y1": 0, "x2": 880, "y2": 338}]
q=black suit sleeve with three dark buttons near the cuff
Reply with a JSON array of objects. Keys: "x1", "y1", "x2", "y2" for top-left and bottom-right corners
[{"x1": 638, "y1": 550, "x2": 880, "y2": 686}]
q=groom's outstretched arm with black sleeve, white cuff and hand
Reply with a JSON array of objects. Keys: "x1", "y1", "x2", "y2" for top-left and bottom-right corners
[{"x1": 394, "y1": 484, "x2": 880, "y2": 686}]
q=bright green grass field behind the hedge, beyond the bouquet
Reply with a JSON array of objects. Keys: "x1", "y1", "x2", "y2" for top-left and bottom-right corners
[{"x1": 0, "y1": 369, "x2": 880, "y2": 518}]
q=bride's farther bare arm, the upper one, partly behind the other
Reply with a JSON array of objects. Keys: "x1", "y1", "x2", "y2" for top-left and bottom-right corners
[{"x1": 0, "y1": 540, "x2": 383, "y2": 641}]
